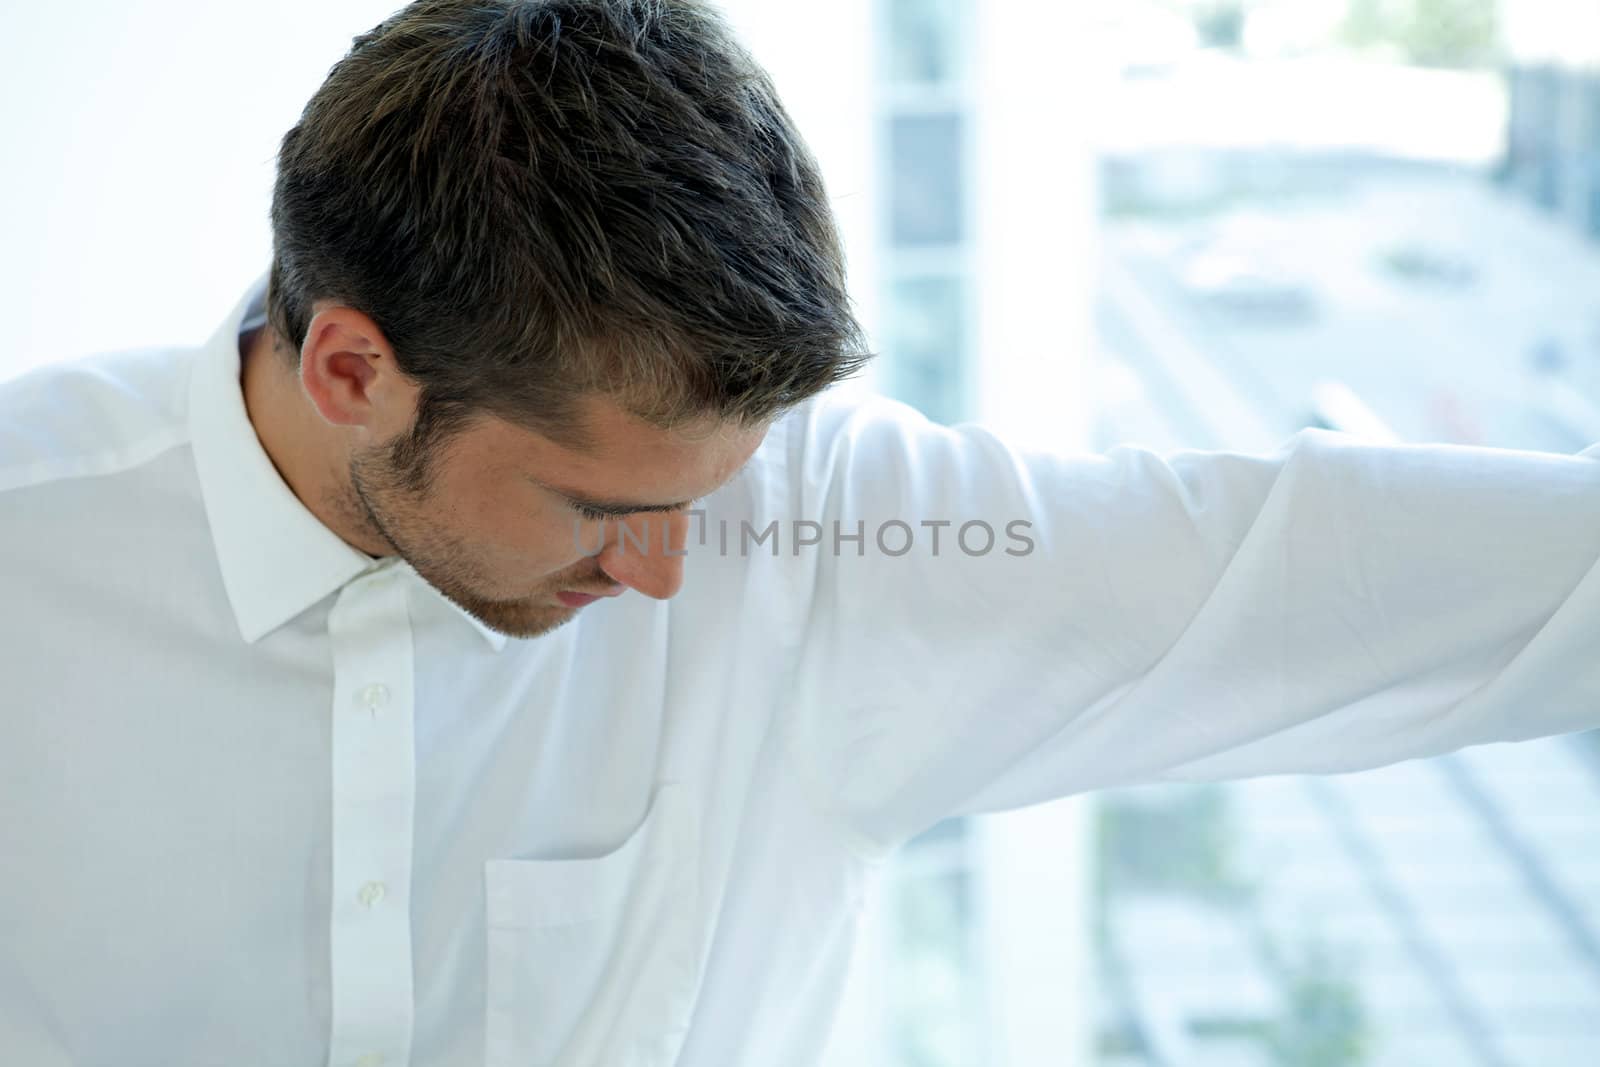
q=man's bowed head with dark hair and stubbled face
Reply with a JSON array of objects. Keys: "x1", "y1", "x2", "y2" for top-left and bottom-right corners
[{"x1": 256, "y1": 0, "x2": 866, "y2": 633}]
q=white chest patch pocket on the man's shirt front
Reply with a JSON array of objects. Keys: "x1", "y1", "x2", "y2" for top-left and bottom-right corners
[{"x1": 483, "y1": 782, "x2": 699, "y2": 1067}]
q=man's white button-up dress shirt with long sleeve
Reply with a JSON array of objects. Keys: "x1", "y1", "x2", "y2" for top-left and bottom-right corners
[{"x1": 0, "y1": 285, "x2": 1600, "y2": 1067}]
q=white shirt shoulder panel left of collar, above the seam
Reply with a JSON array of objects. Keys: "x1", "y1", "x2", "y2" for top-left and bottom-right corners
[{"x1": 0, "y1": 347, "x2": 195, "y2": 493}]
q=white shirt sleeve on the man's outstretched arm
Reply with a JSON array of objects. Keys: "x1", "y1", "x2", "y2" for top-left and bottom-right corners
[{"x1": 764, "y1": 388, "x2": 1600, "y2": 851}]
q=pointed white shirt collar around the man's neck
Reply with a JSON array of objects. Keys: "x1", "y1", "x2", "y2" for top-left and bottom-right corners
[{"x1": 189, "y1": 275, "x2": 506, "y2": 651}]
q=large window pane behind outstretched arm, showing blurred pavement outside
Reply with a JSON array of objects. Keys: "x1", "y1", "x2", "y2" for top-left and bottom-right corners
[{"x1": 1094, "y1": 0, "x2": 1600, "y2": 1067}]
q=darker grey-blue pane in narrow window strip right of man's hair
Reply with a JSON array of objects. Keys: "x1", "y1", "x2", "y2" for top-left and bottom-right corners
[{"x1": 890, "y1": 114, "x2": 965, "y2": 246}]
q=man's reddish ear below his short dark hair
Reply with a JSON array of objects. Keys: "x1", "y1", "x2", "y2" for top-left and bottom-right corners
[{"x1": 299, "y1": 302, "x2": 418, "y2": 443}]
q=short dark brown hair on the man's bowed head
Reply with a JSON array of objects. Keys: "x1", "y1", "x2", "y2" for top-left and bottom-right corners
[{"x1": 267, "y1": 0, "x2": 869, "y2": 483}]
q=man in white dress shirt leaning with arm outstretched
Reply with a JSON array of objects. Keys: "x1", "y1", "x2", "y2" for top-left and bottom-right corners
[{"x1": 0, "y1": 0, "x2": 1600, "y2": 1067}]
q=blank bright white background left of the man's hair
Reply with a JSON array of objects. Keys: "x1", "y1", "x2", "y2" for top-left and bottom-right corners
[{"x1": 0, "y1": 0, "x2": 419, "y2": 379}]
